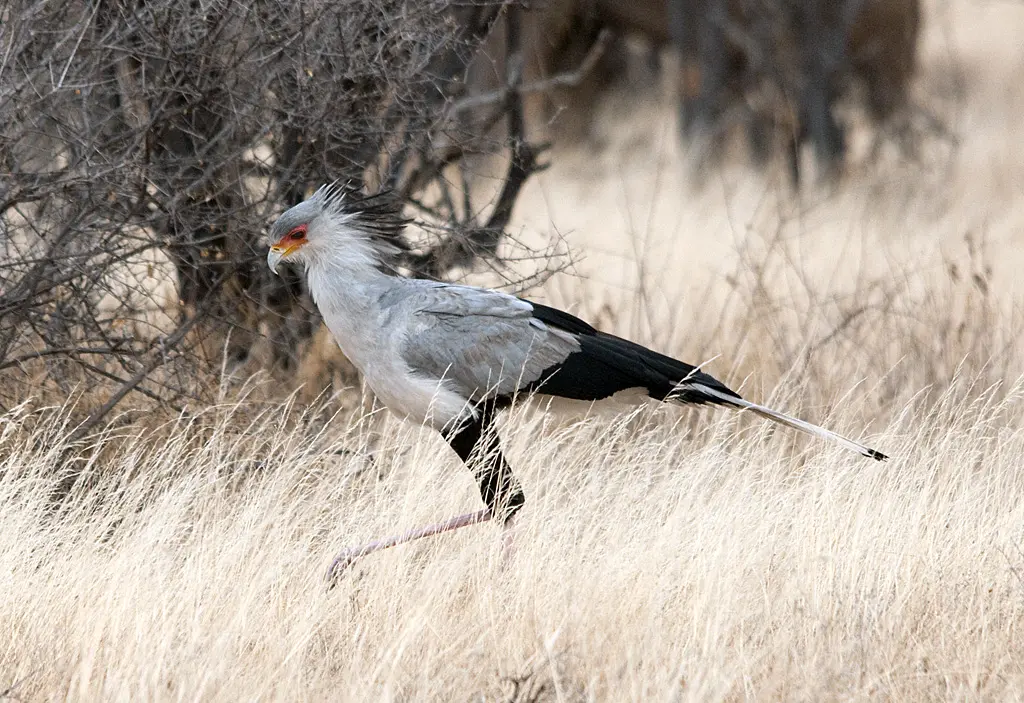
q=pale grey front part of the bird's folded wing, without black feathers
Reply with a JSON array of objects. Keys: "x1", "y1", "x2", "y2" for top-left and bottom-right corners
[{"x1": 401, "y1": 281, "x2": 580, "y2": 401}]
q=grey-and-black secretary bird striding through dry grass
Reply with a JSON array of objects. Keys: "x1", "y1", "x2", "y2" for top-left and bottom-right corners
[{"x1": 267, "y1": 185, "x2": 887, "y2": 579}]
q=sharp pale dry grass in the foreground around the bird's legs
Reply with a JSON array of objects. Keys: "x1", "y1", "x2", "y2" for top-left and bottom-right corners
[{"x1": 0, "y1": 370, "x2": 1024, "y2": 701}]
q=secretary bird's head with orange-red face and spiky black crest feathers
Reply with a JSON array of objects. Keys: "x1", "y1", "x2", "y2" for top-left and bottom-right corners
[{"x1": 266, "y1": 184, "x2": 407, "y2": 273}]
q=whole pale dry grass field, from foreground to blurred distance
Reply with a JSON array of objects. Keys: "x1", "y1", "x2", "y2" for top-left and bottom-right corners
[{"x1": 6, "y1": 0, "x2": 1024, "y2": 701}]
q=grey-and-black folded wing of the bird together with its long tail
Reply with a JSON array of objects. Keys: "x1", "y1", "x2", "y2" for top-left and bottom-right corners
[{"x1": 402, "y1": 281, "x2": 886, "y2": 460}]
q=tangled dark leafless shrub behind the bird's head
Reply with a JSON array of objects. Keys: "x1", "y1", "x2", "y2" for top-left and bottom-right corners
[{"x1": 0, "y1": 0, "x2": 569, "y2": 433}]
